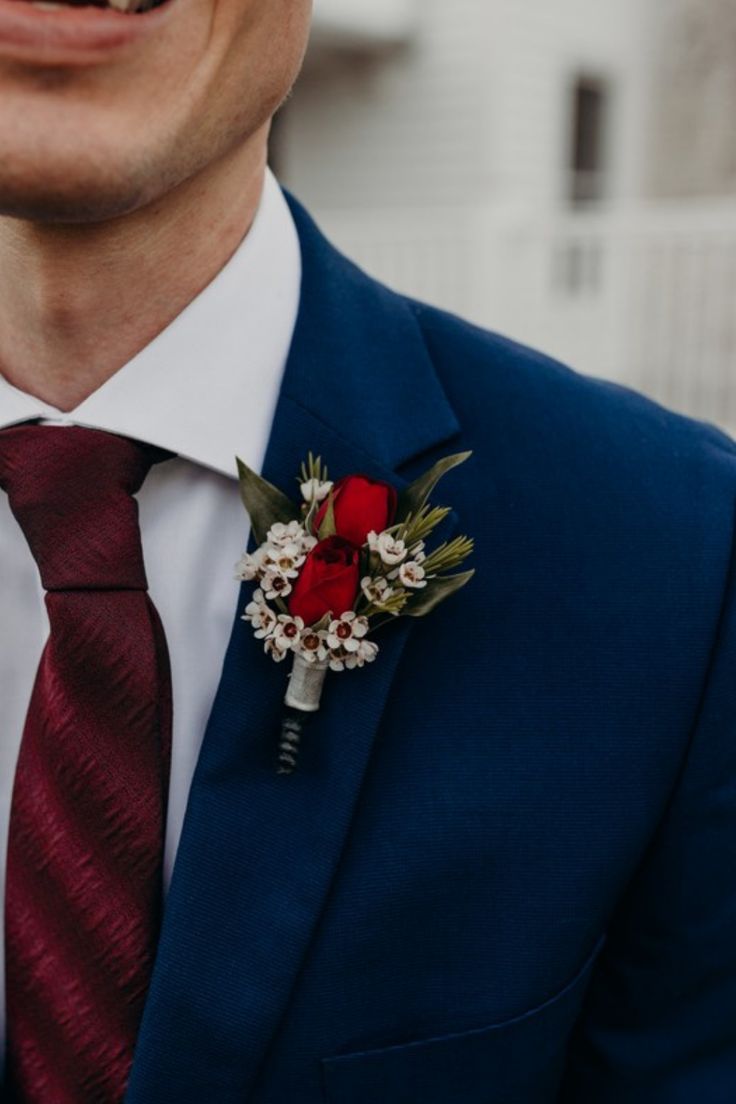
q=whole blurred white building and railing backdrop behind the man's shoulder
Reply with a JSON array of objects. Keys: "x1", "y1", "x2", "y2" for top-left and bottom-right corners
[{"x1": 273, "y1": 0, "x2": 736, "y2": 432}]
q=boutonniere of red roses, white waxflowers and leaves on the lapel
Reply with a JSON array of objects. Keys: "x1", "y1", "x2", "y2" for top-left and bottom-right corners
[{"x1": 235, "y1": 453, "x2": 474, "y2": 774}]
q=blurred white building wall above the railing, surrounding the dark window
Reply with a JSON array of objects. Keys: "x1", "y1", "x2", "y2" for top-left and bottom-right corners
[{"x1": 279, "y1": 0, "x2": 650, "y2": 212}]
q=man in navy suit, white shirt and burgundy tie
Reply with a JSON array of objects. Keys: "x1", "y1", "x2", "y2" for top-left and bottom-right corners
[{"x1": 0, "y1": 0, "x2": 736, "y2": 1104}]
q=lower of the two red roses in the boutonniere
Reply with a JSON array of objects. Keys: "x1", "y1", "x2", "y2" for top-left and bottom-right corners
[{"x1": 289, "y1": 537, "x2": 361, "y2": 625}]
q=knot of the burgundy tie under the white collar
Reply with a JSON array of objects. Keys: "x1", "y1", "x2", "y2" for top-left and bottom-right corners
[{"x1": 0, "y1": 425, "x2": 167, "y2": 591}]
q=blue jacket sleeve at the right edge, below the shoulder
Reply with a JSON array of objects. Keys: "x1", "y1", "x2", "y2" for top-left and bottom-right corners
[{"x1": 559, "y1": 505, "x2": 736, "y2": 1104}]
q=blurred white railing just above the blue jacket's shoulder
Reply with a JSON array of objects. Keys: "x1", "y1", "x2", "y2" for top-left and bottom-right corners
[{"x1": 313, "y1": 202, "x2": 736, "y2": 431}]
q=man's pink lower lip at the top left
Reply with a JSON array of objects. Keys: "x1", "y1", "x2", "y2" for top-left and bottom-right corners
[{"x1": 0, "y1": 0, "x2": 175, "y2": 65}]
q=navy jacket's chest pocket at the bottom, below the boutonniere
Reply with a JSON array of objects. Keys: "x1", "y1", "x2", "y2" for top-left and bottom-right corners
[{"x1": 321, "y1": 938, "x2": 604, "y2": 1104}]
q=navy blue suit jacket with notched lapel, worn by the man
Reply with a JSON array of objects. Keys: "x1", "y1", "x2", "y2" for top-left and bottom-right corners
[{"x1": 127, "y1": 194, "x2": 736, "y2": 1104}]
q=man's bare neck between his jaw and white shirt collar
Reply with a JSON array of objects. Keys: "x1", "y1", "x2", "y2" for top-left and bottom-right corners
[{"x1": 0, "y1": 130, "x2": 266, "y2": 411}]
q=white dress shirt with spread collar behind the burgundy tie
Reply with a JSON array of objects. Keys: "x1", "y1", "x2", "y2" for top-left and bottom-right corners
[{"x1": 0, "y1": 163, "x2": 301, "y2": 1041}]
